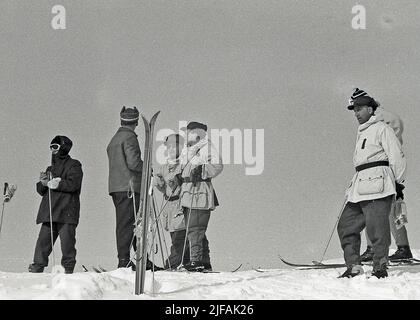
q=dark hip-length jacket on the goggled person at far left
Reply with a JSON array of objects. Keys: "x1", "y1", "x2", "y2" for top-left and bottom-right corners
[{"x1": 36, "y1": 155, "x2": 83, "y2": 225}]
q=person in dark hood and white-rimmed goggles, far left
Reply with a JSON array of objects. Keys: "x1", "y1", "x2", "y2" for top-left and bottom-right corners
[{"x1": 29, "y1": 136, "x2": 83, "y2": 273}]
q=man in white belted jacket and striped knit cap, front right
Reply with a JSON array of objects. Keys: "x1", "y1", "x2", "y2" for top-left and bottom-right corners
[{"x1": 337, "y1": 96, "x2": 406, "y2": 278}]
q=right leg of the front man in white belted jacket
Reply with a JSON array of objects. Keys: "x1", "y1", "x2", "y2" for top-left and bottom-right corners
[{"x1": 360, "y1": 196, "x2": 393, "y2": 270}]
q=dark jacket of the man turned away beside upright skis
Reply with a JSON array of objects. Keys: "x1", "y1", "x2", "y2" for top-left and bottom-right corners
[{"x1": 106, "y1": 127, "x2": 143, "y2": 194}]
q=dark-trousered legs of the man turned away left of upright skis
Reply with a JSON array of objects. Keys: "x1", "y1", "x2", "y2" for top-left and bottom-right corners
[{"x1": 112, "y1": 192, "x2": 137, "y2": 267}]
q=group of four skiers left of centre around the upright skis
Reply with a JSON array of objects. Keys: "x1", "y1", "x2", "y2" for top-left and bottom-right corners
[{"x1": 29, "y1": 107, "x2": 223, "y2": 273}]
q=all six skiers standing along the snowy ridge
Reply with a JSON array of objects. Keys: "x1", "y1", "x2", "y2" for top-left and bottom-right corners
[{"x1": 20, "y1": 88, "x2": 412, "y2": 278}]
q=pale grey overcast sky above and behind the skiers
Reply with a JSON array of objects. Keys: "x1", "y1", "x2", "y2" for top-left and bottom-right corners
[{"x1": 0, "y1": 0, "x2": 420, "y2": 271}]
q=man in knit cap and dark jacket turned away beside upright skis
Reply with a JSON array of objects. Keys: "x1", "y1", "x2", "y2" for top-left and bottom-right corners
[{"x1": 107, "y1": 107, "x2": 143, "y2": 269}]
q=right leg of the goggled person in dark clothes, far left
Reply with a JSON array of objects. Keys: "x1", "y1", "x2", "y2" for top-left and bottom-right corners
[{"x1": 58, "y1": 223, "x2": 77, "y2": 273}]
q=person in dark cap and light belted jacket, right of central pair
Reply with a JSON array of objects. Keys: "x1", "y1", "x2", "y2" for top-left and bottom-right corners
[{"x1": 178, "y1": 121, "x2": 223, "y2": 272}]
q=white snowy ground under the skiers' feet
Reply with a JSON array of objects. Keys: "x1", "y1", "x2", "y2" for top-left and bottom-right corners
[{"x1": 0, "y1": 250, "x2": 420, "y2": 300}]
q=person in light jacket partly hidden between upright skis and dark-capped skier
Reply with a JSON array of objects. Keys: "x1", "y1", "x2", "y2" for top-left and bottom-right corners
[{"x1": 155, "y1": 134, "x2": 190, "y2": 269}]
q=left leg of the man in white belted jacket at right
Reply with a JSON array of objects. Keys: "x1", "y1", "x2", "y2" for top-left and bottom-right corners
[{"x1": 337, "y1": 202, "x2": 365, "y2": 267}]
